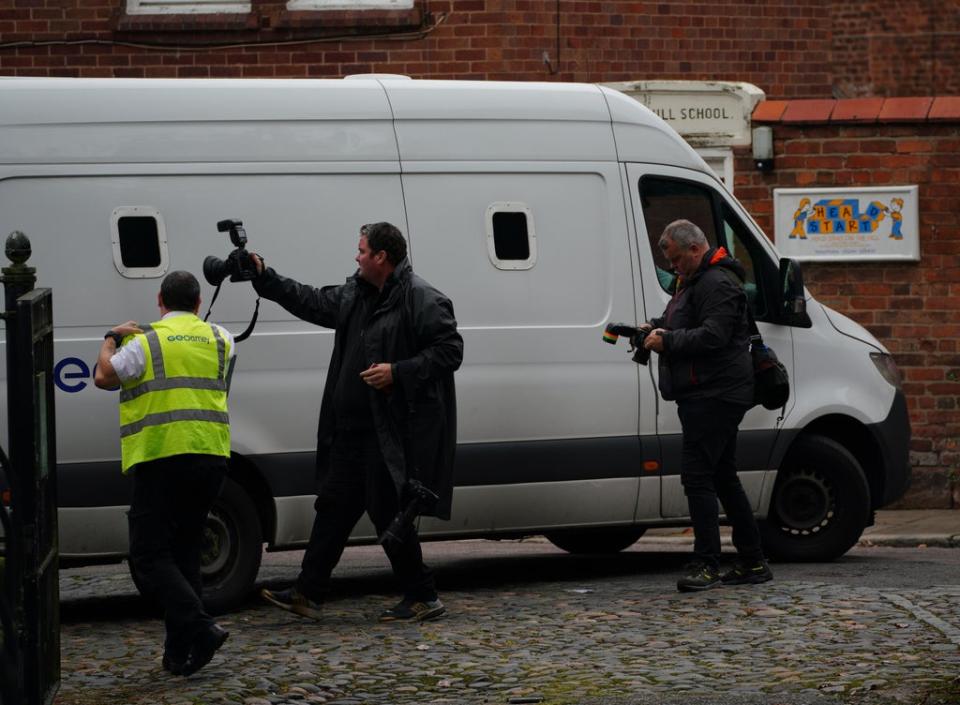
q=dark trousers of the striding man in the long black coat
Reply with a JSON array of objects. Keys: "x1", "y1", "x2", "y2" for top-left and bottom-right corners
[{"x1": 297, "y1": 431, "x2": 437, "y2": 601}]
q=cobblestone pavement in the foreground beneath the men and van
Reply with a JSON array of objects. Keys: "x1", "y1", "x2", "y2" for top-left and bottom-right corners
[{"x1": 55, "y1": 542, "x2": 960, "y2": 705}]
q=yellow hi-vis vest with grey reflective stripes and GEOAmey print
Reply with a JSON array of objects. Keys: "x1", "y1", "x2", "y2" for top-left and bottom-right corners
[{"x1": 120, "y1": 314, "x2": 230, "y2": 473}]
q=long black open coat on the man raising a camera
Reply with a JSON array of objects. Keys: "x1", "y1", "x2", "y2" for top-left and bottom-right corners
[{"x1": 253, "y1": 259, "x2": 463, "y2": 519}]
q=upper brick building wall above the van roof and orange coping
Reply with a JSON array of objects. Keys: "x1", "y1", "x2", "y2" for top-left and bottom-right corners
[{"x1": 0, "y1": 0, "x2": 960, "y2": 98}]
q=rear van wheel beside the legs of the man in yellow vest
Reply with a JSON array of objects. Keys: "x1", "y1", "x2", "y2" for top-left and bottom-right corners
[{"x1": 200, "y1": 477, "x2": 263, "y2": 614}]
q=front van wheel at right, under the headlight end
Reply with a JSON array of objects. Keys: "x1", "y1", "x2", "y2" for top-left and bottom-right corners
[{"x1": 760, "y1": 435, "x2": 870, "y2": 561}]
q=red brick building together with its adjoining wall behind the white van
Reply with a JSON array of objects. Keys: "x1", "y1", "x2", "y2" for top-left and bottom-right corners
[{"x1": 0, "y1": 0, "x2": 960, "y2": 507}]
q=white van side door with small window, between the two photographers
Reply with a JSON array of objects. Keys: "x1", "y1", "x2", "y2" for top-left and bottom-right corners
[{"x1": 403, "y1": 162, "x2": 659, "y2": 536}]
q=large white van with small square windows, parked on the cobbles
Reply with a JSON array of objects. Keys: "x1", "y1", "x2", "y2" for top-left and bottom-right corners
[{"x1": 0, "y1": 76, "x2": 910, "y2": 609}]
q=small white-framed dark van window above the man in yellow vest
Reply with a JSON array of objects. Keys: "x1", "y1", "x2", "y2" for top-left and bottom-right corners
[{"x1": 110, "y1": 206, "x2": 168, "y2": 279}]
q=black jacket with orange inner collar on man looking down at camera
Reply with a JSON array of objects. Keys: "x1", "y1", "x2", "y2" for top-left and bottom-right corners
[{"x1": 650, "y1": 248, "x2": 753, "y2": 406}]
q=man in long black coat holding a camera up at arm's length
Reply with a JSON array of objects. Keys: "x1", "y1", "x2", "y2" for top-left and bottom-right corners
[{"x1": 251, "y1": 223, "x2": 463, "y2": 622}]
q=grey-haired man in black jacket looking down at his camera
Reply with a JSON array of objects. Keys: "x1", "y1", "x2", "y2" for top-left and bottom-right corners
[{"x1": 642, "y1": 220, "x2": 773, "y2": 592}]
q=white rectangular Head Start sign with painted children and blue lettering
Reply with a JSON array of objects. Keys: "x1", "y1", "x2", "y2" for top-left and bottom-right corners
[{"x1": 774, "y1": 186, "x2": 920, "y2": 261}]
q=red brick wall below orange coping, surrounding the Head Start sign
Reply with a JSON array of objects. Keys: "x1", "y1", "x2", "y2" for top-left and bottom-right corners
[{"x1": 735, "y1": 122, "x2": 960, "y2": 508}]
